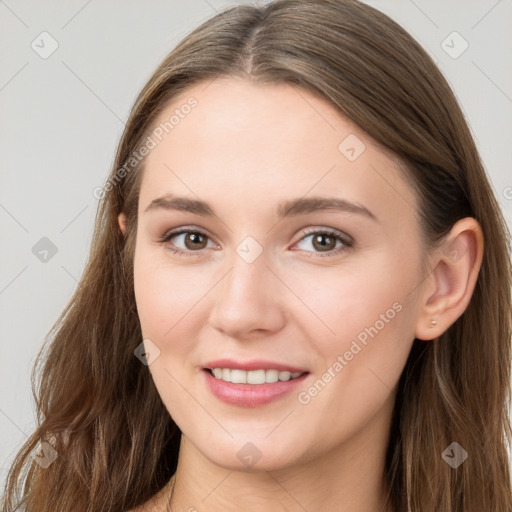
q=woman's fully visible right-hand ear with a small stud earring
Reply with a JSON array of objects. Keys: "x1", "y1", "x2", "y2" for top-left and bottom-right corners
[{"x1": 415, "y1": 217, "x2": 484, "y2": 340}]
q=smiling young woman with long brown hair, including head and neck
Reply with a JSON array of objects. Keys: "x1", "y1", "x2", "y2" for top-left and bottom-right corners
[{"x1": 4, "y1": 0, "x2": 512, "y2": 512}]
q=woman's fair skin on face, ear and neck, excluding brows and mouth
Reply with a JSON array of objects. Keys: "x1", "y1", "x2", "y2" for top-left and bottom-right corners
[{"x1": 119, "y1": 77, "x2": 483, "y2": 512}]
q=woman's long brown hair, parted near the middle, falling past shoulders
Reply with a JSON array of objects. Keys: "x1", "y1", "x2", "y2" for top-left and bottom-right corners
[{"x1": 2, "y1": 0, "x2": 512, "y2": 512}]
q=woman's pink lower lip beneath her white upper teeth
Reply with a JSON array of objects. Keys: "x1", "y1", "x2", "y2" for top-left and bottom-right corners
[{"x1": 203, "y1": 370, "x2": 309, "y2": 407}]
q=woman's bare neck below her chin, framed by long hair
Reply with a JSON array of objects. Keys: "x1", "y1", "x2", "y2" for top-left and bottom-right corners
[{"x1": 170, "y1": 392, "x2": 393, "y2": 512}]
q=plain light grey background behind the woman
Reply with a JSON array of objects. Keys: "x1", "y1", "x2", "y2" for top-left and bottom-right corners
[{"x1": 0, "y1": 0, "x2": 512, "y2": 492}]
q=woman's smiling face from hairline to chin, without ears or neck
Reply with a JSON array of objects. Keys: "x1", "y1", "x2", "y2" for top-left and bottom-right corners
[{"x1": 129, "y1": 78, "x2": 423, "y2": 469}]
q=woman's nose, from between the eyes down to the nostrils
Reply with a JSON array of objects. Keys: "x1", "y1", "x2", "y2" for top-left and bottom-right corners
[{"x1": 210, "y1": 249, "x2": 287, "y2": 339}]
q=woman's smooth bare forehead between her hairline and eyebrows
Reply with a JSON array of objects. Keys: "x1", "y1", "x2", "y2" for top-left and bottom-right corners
[{"x1": 140, "y1": 77, "x2": 416, "y2": 226}]
